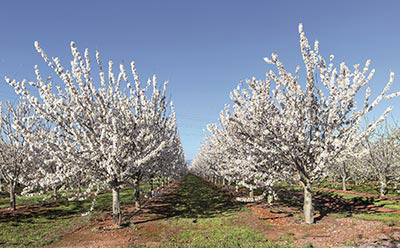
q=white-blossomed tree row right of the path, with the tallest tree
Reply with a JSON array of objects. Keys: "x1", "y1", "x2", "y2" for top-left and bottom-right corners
[{"x1": 191, "y1": 24, "x2": 398, "y2": 223}]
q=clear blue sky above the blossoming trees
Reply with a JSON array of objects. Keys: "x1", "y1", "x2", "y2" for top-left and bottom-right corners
[{"x1": 0, "y1": 0, "x2": 400, "y2": 159}]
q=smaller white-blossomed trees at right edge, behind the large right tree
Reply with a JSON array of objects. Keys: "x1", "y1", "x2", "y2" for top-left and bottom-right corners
[{"x1": 328, "y1": 123, "x2": 400, "y2": 196}]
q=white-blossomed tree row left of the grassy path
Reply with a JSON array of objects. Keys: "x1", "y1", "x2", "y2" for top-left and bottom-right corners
[{"x1": 0, "y1": 42, "x2": 186, "y2": 224}]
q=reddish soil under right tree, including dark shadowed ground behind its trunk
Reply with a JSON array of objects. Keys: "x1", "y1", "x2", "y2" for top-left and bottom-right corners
[{"x1": 217, "y1": 183, "x2": 400, "y2": 248}]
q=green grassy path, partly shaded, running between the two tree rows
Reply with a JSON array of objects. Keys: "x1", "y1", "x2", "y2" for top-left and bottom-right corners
[{"x1": 152, "y1": 175, "x2": 275, "y2": 247}]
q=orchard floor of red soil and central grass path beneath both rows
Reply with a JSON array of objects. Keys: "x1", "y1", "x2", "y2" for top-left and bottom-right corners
[{"x1": 0, "y1": 175, "x2": 400, "y2": 247}]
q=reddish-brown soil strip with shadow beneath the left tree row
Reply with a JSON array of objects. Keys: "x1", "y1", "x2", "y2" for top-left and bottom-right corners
[{"x1": 48, "y1": 183, "x2": 183, "y2": 247}]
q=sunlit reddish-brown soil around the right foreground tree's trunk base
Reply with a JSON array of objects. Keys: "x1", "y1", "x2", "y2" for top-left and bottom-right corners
[{"x1": 240, "y1": 204, "x2": 400, "y2": 247}]
